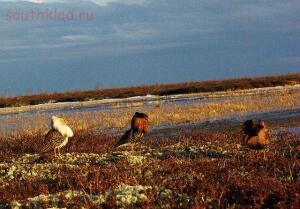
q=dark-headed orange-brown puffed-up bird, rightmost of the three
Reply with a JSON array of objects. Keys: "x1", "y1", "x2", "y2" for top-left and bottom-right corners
[{"x1": 243, "y1": 120, "x2": 269, "y2": 149}]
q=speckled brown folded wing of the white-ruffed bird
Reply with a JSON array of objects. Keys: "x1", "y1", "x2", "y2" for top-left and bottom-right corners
[{"x1": 42, "y1": 129, "x2": 64, "y2": 152}]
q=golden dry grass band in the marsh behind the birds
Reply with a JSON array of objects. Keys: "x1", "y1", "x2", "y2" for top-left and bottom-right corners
[{"x1": 0, "y1": 86, "x2": 300, "y2": 138}]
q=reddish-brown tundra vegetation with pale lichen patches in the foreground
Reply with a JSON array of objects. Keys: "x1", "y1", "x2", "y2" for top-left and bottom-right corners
[{"x1": 0, "y1": 128, "x2": 300, "y2": 208}]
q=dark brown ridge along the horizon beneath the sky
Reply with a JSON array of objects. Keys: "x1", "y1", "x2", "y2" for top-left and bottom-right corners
[{"x1": 0, "y1": 73, "x2": 300, "y2": 108}]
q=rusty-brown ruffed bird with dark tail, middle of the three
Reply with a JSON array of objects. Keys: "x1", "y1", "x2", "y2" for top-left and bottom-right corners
[{"x1": 115, "y1": 112, "x2": 149, "y2": 147}]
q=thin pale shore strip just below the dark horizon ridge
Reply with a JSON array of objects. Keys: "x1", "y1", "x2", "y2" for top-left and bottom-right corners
[{"x1": 0, "y1": 84, "x2": 300, "y2": 115}]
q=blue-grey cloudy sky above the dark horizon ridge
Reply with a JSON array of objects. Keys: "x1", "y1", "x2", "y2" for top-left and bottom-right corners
[{"x1": 0, "y1": 0, "x2": 300, "y2": 96}]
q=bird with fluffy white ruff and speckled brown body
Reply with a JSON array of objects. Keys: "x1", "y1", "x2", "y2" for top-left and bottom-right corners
[{"x1": 42, "y1": 116, "x2": 74, "y2": 156}]
